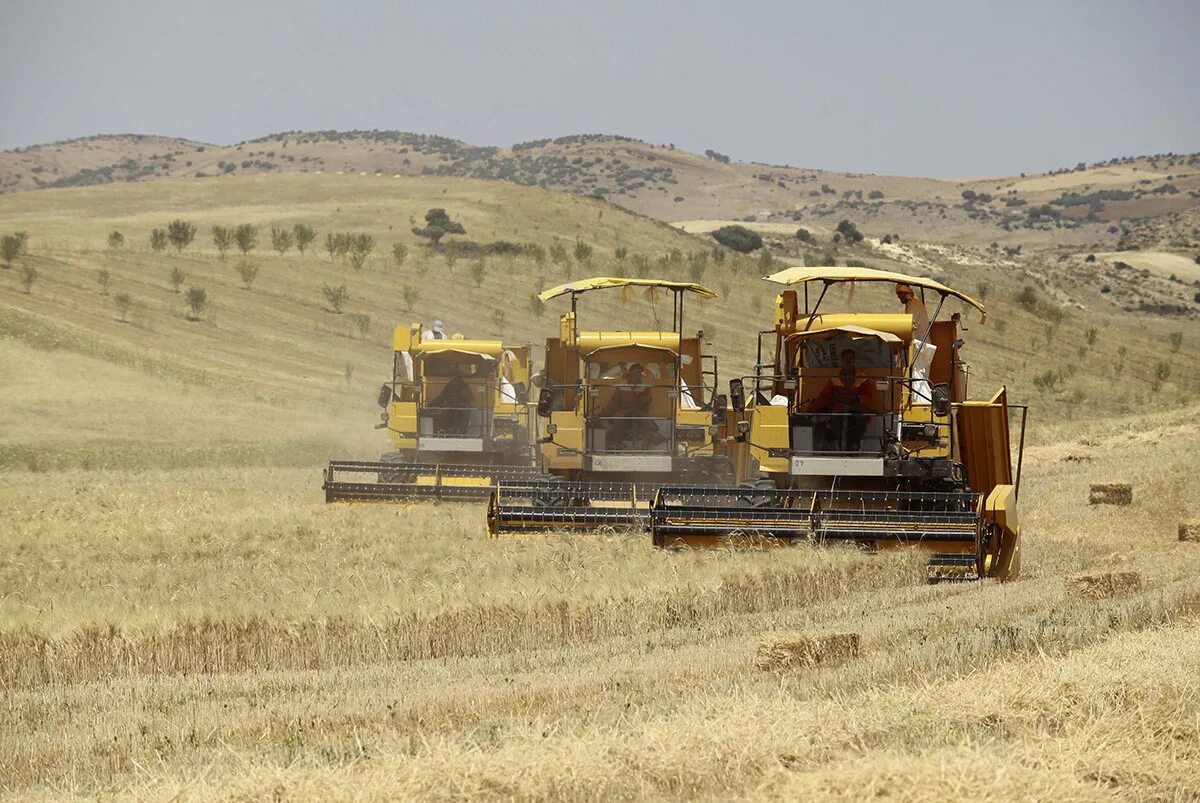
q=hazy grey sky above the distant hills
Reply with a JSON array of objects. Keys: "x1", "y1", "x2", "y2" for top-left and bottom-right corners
[{"x1": 0, "y1": 0, "x2": 1200, "y2": 176}]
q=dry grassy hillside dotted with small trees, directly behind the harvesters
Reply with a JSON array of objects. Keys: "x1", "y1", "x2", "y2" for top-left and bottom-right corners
[{"x1": 0, "y1": 174, "x2": 1200, "y2": 466}]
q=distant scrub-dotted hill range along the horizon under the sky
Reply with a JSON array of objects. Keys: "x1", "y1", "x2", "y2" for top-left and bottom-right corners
[{"x1": 0, "y1": 131, "x2": 1200, "y2": 247}]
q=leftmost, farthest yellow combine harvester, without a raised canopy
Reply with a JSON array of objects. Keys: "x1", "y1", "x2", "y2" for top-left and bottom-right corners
[{"x1": 324, "y1": 324, "x2": 538, "y2": 502}]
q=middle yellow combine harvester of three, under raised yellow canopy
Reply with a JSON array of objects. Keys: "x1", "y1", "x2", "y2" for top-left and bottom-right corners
[{"x1": 487, "y1": 277, "x2": 733, "y2": 535}]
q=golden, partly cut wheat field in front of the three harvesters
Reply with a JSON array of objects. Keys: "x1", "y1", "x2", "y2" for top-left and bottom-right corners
[{"x1": 0, "y1": 408, "x2": 1200, "y2": 799}]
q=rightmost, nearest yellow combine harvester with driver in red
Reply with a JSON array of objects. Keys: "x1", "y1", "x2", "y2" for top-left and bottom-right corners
[{"x1": 649, "y1": 268, "x2": 1027, "y2": 581}]
